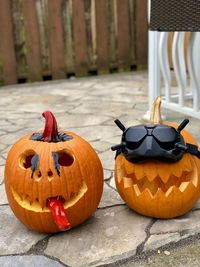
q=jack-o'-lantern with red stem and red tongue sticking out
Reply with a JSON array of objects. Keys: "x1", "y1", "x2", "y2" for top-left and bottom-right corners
[{"x1": 5, "y1": 111, "x2": 103, "y2": 233}]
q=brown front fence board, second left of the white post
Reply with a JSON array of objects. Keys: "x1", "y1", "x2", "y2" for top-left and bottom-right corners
[{"x1": 117, "y1": 0, "x2": 131, "y2": 69}]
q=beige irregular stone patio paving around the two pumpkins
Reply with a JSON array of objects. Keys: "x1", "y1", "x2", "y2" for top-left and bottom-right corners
[{"x1": 0, "y1": 72, "x2": 200, "y2": 267}]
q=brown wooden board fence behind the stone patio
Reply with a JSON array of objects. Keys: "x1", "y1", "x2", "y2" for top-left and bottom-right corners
[{"x1": 0, "y1": 0, "x2": 147, "y2": 84}]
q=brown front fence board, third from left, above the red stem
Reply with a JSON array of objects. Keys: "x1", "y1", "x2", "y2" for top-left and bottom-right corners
[{"x1": 47, "y1": 0, "x2": 66, "y2": 79}]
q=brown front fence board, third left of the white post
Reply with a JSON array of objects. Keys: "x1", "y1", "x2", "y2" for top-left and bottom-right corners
[{"x1": 95, "y1": 0, "x2": 109, "y2": 73}]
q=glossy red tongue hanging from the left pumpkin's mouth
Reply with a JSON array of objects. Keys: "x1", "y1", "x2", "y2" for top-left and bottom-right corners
[{"x1": 47, "y1": 198, "x2": 71, "y2": 231}]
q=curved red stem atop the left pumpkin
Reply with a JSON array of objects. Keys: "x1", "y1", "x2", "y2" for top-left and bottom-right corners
[{"x1": 42, "y1": 111, "x2": 58, "y2": 142}]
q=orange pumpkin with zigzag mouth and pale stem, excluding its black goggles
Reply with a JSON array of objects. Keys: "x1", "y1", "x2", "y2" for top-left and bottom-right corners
[{"x1": 112, "y1": 98, "x2": 200, "y2": 218}]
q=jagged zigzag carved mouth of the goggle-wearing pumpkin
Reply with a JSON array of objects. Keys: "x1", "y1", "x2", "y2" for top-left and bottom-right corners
[{"x1": 122, "y1": 170, "x2": 198, "y2": 196}]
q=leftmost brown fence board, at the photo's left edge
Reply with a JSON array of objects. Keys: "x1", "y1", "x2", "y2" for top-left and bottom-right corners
[{"x1": 0, "y1": 0, "x2": 17, "y2": 84}]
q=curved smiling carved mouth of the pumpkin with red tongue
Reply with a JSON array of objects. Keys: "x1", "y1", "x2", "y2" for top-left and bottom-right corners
[{"x1": 11, "y1": 182, "x2": 88, "y2": 212}]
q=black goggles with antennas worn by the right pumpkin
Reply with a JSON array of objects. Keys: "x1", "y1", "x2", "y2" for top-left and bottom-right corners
[{"x1": 111, "y1": 119, "x2": 200, "y2": 162}]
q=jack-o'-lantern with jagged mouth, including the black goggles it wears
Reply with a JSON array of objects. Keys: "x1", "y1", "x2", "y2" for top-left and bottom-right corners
[{"x1": 112, "y1": 98, "x2": 200, "y2": 218}]
